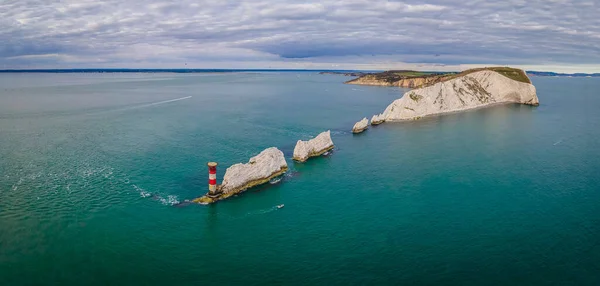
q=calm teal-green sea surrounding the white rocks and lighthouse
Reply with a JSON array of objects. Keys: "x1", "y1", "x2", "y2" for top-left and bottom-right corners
[{"x1": 0, "y1": 72, "x2": 600, "y2": 286}]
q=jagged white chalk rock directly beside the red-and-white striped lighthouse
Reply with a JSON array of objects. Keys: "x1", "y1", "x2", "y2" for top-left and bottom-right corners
[{"x1": 194, "y1": 147, "x2": 288, "y2": 204}]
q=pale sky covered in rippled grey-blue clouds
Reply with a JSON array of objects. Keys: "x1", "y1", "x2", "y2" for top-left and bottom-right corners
[{"x1": 0, "y1": 0, "x2": 600, "y2": 72}]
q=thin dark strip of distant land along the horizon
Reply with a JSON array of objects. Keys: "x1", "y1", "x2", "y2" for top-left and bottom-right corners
[{"x1": 0, "y1": 68, "x2": 600, "y2": 77}]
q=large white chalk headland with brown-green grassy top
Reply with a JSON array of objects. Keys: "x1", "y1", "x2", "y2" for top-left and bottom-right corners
[{"x1": 383, "y1": 67, "x2": 539, "y2": 121}]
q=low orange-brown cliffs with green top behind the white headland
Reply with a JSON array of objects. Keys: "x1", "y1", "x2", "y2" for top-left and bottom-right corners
[{"x1": 346, "y1": 71, "x2": 452, "y2": 88}]
